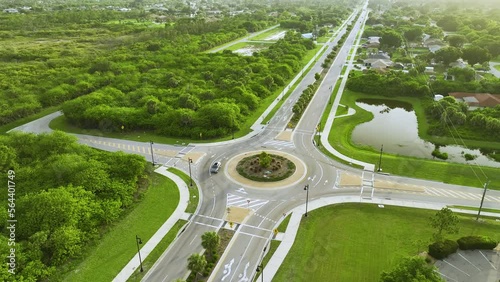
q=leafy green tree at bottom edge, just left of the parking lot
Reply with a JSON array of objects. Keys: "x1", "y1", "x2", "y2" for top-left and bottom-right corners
[{"x1": 380, "y1": 256, "x2": 443, "y2": 282}]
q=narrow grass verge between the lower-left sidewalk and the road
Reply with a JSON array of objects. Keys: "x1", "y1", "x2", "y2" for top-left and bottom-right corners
[{"x1": 127, "y1": 219, "x2": 187, "y2": 282}]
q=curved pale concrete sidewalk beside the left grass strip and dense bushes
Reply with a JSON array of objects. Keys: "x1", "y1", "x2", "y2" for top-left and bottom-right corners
[{"x1": 113, "y1": 169, "x2": 189, "y2": 282}]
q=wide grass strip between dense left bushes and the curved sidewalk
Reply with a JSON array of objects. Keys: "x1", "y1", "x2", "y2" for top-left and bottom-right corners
[{"x1": 64, "y1": 173, "x2": 179, "y2": 282}]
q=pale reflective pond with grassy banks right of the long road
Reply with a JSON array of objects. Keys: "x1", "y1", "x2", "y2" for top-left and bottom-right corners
[{"x1": 351, "y1": 99, "x2": 500, "y2": 167}]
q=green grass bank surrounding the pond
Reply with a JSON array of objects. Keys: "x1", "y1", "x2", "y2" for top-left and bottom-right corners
[{"x1": 328, "y1": 90, "x2": 500, "y2": 190}]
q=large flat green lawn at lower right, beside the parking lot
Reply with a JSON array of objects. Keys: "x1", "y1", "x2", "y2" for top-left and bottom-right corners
[{"x1": 273, "y1": 204, "x2": 500, "y2": 282}]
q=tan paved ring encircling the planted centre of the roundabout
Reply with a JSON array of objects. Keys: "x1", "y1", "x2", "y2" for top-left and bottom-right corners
[{"x1": 224, "y1": 150, "x2": 307, "y2": 189}]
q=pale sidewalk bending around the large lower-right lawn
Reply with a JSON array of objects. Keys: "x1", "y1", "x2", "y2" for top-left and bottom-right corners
[{"x1": 256, "y1": 196, "x2": 500, "y2": 282}]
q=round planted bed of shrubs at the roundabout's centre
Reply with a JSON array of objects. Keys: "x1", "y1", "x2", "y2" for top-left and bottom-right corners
[{"x1": 236, "y1": 151, "x2": 296, "y2": 182}]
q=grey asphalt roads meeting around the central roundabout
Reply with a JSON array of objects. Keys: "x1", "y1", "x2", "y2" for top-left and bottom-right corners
[{"x1": 8, "y1": 2, "x2": 500, "y2": 282}]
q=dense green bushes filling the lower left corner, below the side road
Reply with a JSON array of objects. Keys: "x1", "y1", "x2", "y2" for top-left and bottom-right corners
[{"x1": 0, "y1": 131, "x2": 147, "y2": 281}]
